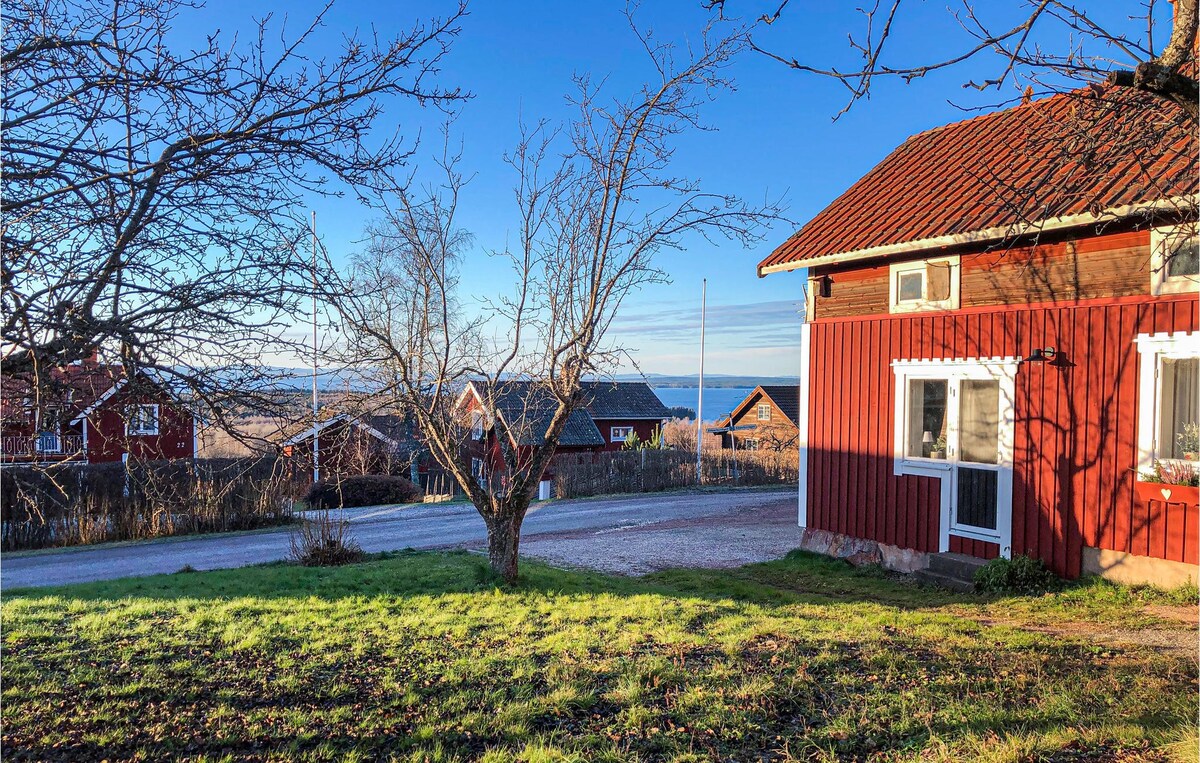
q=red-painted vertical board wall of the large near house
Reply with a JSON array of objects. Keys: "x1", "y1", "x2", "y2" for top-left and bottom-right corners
[{"x1": 808, "y1": 295, "x2": 1200, "y2": 577}]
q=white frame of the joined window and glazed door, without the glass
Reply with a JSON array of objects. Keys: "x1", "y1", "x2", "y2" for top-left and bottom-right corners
[{"x1": 892, "y1": 356, "x2": 1021, "y2": 558}]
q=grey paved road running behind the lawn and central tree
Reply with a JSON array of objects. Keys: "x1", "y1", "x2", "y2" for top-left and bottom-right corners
[{"x1": 0, "y1": 489, "x2": 796, "y2": 589}]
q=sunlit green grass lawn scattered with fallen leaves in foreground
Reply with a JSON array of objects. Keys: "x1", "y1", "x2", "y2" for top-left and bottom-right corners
[{"x1": 2, "y1": 553, "x2": 1198, "y2": 762}]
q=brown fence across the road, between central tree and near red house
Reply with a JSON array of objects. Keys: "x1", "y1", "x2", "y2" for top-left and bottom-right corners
[{"x1": 550, "y1": 449, "x2": 797, "y2": 498}]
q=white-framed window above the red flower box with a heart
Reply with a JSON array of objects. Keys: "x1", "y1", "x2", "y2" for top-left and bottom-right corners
[{"x1": 1136, "y1": 331, "x2": 1200, "y2": 476}]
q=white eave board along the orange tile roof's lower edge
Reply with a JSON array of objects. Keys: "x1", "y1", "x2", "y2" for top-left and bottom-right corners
[{"x1": 758, "y1": 193, "x2": 1200, "y2": 277}]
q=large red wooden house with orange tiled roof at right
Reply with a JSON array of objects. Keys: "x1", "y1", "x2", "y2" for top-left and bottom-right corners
[{"x1": 758, "y1": 89, "x2": 1200, "y2": 583}]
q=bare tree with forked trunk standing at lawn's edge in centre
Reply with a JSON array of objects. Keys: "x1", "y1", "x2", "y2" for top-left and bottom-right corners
[{"x1": 332, "y1": 22, "x2": 779, "y2": 581}]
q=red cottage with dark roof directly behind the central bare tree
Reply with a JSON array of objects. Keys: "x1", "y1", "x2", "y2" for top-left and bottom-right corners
[{"x1": 457, "y1": 380, "x2": 671, "y2": 489}]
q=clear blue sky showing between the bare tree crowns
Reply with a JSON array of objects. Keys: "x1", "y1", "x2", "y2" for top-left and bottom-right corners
[{"x1": 192, "y1": 0, "x2": 1156, "y2": 374}]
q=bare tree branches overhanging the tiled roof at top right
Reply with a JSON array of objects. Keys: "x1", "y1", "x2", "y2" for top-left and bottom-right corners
[{"x1": 706, "y1": 0, "x2": 1200, "y2": 124}]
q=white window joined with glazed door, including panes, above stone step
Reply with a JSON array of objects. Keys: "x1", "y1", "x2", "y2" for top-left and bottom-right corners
[{"x1": 892, "y1": 358, "x2": 1019, "y2": 557}]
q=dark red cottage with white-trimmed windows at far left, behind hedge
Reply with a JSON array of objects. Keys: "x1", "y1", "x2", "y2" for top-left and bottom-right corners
[{"x1": 0, "y1": 355, "x2": 196, "y2": 463}]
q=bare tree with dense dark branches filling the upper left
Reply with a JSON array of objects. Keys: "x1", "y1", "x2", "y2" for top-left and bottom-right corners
[{"x1": 0, "y1": 0, "x2": 463, "y2": 429}]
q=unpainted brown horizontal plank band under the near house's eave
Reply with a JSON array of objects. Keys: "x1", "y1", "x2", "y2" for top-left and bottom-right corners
[{"x1": 811, "y1": 230, "x2": 1150, "y2": 320}]
